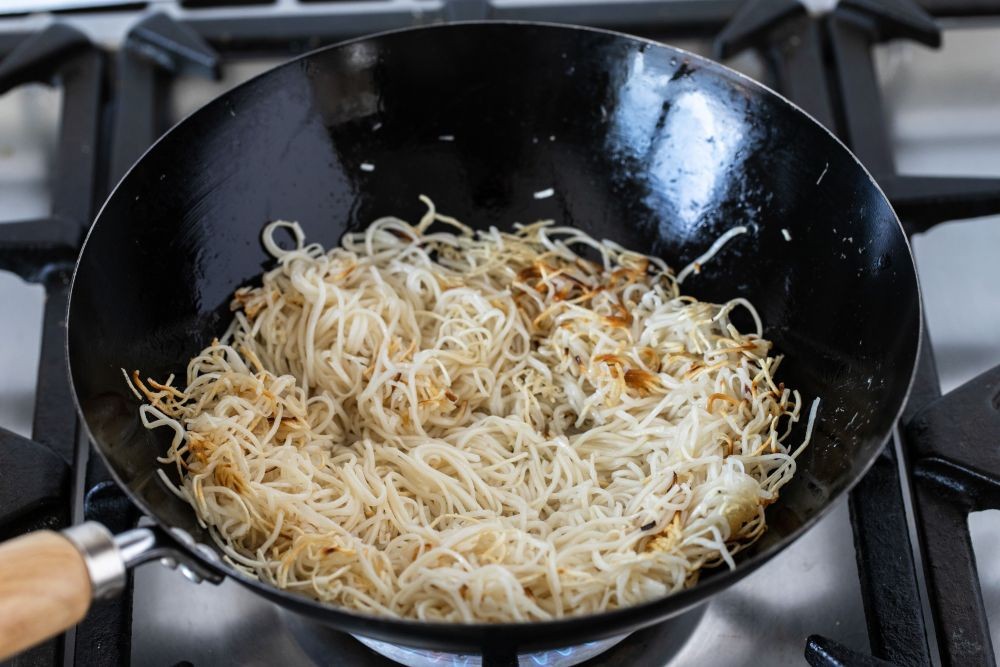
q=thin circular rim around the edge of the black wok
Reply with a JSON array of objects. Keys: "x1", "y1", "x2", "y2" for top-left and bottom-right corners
[{"x1": 64, "y1": 19, "x2": 925, "y2": 648}]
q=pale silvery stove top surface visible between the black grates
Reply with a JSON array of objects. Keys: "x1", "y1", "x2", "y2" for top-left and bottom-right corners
[{"x1": 0, "y1": 3, "x2": 1000, "y2": 667}]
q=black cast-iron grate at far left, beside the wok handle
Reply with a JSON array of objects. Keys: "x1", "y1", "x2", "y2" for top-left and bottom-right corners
[{"x1": 0, "y1": 20, "x2": 104, "y2": 665}]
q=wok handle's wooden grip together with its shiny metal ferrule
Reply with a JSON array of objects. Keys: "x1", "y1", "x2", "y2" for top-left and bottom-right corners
[{"x1": 0, "y1": 523, "x2": 125, "y2": 661}]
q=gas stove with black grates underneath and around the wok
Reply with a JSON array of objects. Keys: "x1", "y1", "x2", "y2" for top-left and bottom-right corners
[{"x1": 0, "y1": 0, "x2": 1000, "y2": 667}]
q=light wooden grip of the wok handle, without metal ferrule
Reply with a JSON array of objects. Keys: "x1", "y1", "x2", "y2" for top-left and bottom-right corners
[{"x1": 0, "y1": 530, "x2": 90, "y2": 661}]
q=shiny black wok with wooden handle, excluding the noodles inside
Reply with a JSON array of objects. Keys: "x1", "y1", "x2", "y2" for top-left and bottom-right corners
[{"x1": 0, "y1": 23, "x2": 921, "y2": 667}]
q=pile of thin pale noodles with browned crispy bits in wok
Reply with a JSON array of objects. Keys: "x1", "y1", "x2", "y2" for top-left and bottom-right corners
[{"x1": 132, "y1": 199, "x2": 816, "y2": 622}]
